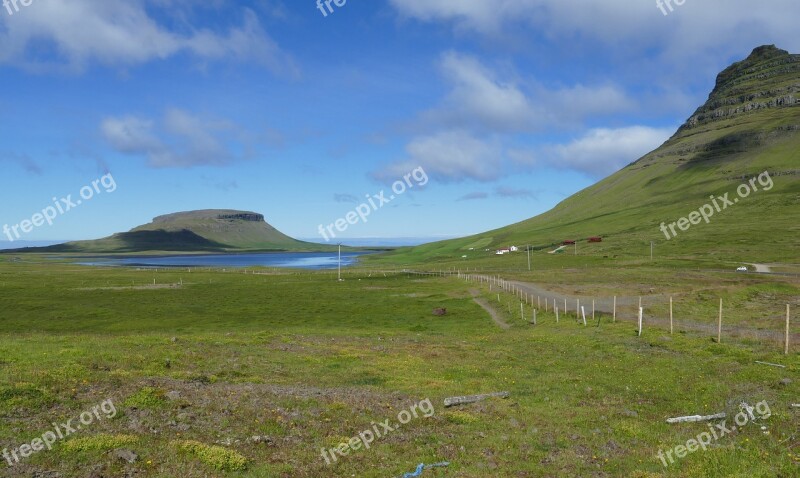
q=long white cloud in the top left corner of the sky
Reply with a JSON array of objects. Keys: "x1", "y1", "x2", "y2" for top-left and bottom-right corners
[{"x1": 0, "y1": 0, "x2": 296, "y2": 74}]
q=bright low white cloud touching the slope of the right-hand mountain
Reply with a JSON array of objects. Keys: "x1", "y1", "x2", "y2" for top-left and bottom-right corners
[{"x1": 550, "y1": 126, "x2": 675, "y2": 177}]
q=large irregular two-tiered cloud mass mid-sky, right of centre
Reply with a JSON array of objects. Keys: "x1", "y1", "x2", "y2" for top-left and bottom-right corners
[{"x1": 373, "y1": 52, "x2": 648, "y2": 182}]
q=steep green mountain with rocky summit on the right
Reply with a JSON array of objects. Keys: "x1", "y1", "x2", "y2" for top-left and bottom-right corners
[{"x1": 388, "y1": 46, "x2": 800, "y2": 262}]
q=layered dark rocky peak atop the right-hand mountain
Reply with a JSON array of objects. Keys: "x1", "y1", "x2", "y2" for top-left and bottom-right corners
[{"x1": 679, "y1": 45, "x2": 800, "y2": 133}]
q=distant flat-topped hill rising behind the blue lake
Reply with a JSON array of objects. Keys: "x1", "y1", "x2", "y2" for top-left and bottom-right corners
[{"x1": 14, "y1": 209, "x2": 333, "y2": 253}]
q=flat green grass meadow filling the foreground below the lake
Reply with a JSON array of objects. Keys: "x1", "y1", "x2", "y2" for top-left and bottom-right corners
[{"x1": 0, "y1": 261, "x2": 800, "y2": 477}]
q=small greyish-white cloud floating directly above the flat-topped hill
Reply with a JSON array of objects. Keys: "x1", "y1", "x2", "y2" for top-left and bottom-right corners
[{"x1": 100, "y1": 109, "x2": 247, "y2": 168}]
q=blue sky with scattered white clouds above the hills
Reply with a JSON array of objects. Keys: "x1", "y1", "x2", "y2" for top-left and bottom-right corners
[{"x1": 0, "y1": 0, "x2": 800, "y2": 243}]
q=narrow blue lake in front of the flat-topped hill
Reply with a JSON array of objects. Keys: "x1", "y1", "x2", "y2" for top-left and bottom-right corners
[{"x1": 78, "y1": 252, "x2": 370, "y2": 269}]
